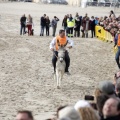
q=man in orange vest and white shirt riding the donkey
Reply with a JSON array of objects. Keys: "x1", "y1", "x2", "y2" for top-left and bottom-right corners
[{"x1": 50, "y1": 30, "x2": 73, "y2": 75}]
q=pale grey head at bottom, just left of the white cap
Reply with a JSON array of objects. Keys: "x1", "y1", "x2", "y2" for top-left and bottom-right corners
[{"x1": 59, "y1": 106, "x2": 80, "y2": 120}]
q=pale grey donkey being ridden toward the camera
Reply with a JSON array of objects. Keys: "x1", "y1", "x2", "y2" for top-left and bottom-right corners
[{"x1": 55, "y1": 46, "x2": 66, "y2": 89}]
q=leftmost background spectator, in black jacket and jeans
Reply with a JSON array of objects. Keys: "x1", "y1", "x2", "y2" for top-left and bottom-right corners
[{"x1": 20, "y1": 14, "x2": 26, "y2": 35}]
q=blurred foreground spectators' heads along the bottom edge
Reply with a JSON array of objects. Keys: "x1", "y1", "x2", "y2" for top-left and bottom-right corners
[{"x1": 16, "y1": 71, "x2": 120, "y2": 120}]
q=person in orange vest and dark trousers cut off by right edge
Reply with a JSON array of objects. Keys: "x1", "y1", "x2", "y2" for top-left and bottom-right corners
[{"x1": 114, "y1": 29, "x2": 120, "y2": 69}]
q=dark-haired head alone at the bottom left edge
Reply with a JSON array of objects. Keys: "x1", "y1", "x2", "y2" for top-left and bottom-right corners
[{"x1": 16, "y1": 110, "x2": 34, "y2": 120}]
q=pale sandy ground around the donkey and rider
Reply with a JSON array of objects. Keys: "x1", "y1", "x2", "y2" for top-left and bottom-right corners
[{"x1": 0, "y1": 2, "x2": 118, "y2": 120}]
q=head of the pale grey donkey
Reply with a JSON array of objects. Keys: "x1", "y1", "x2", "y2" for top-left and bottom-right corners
[{"x1": 58, "y1": 45, "x2": 66, "y2": 62}]
